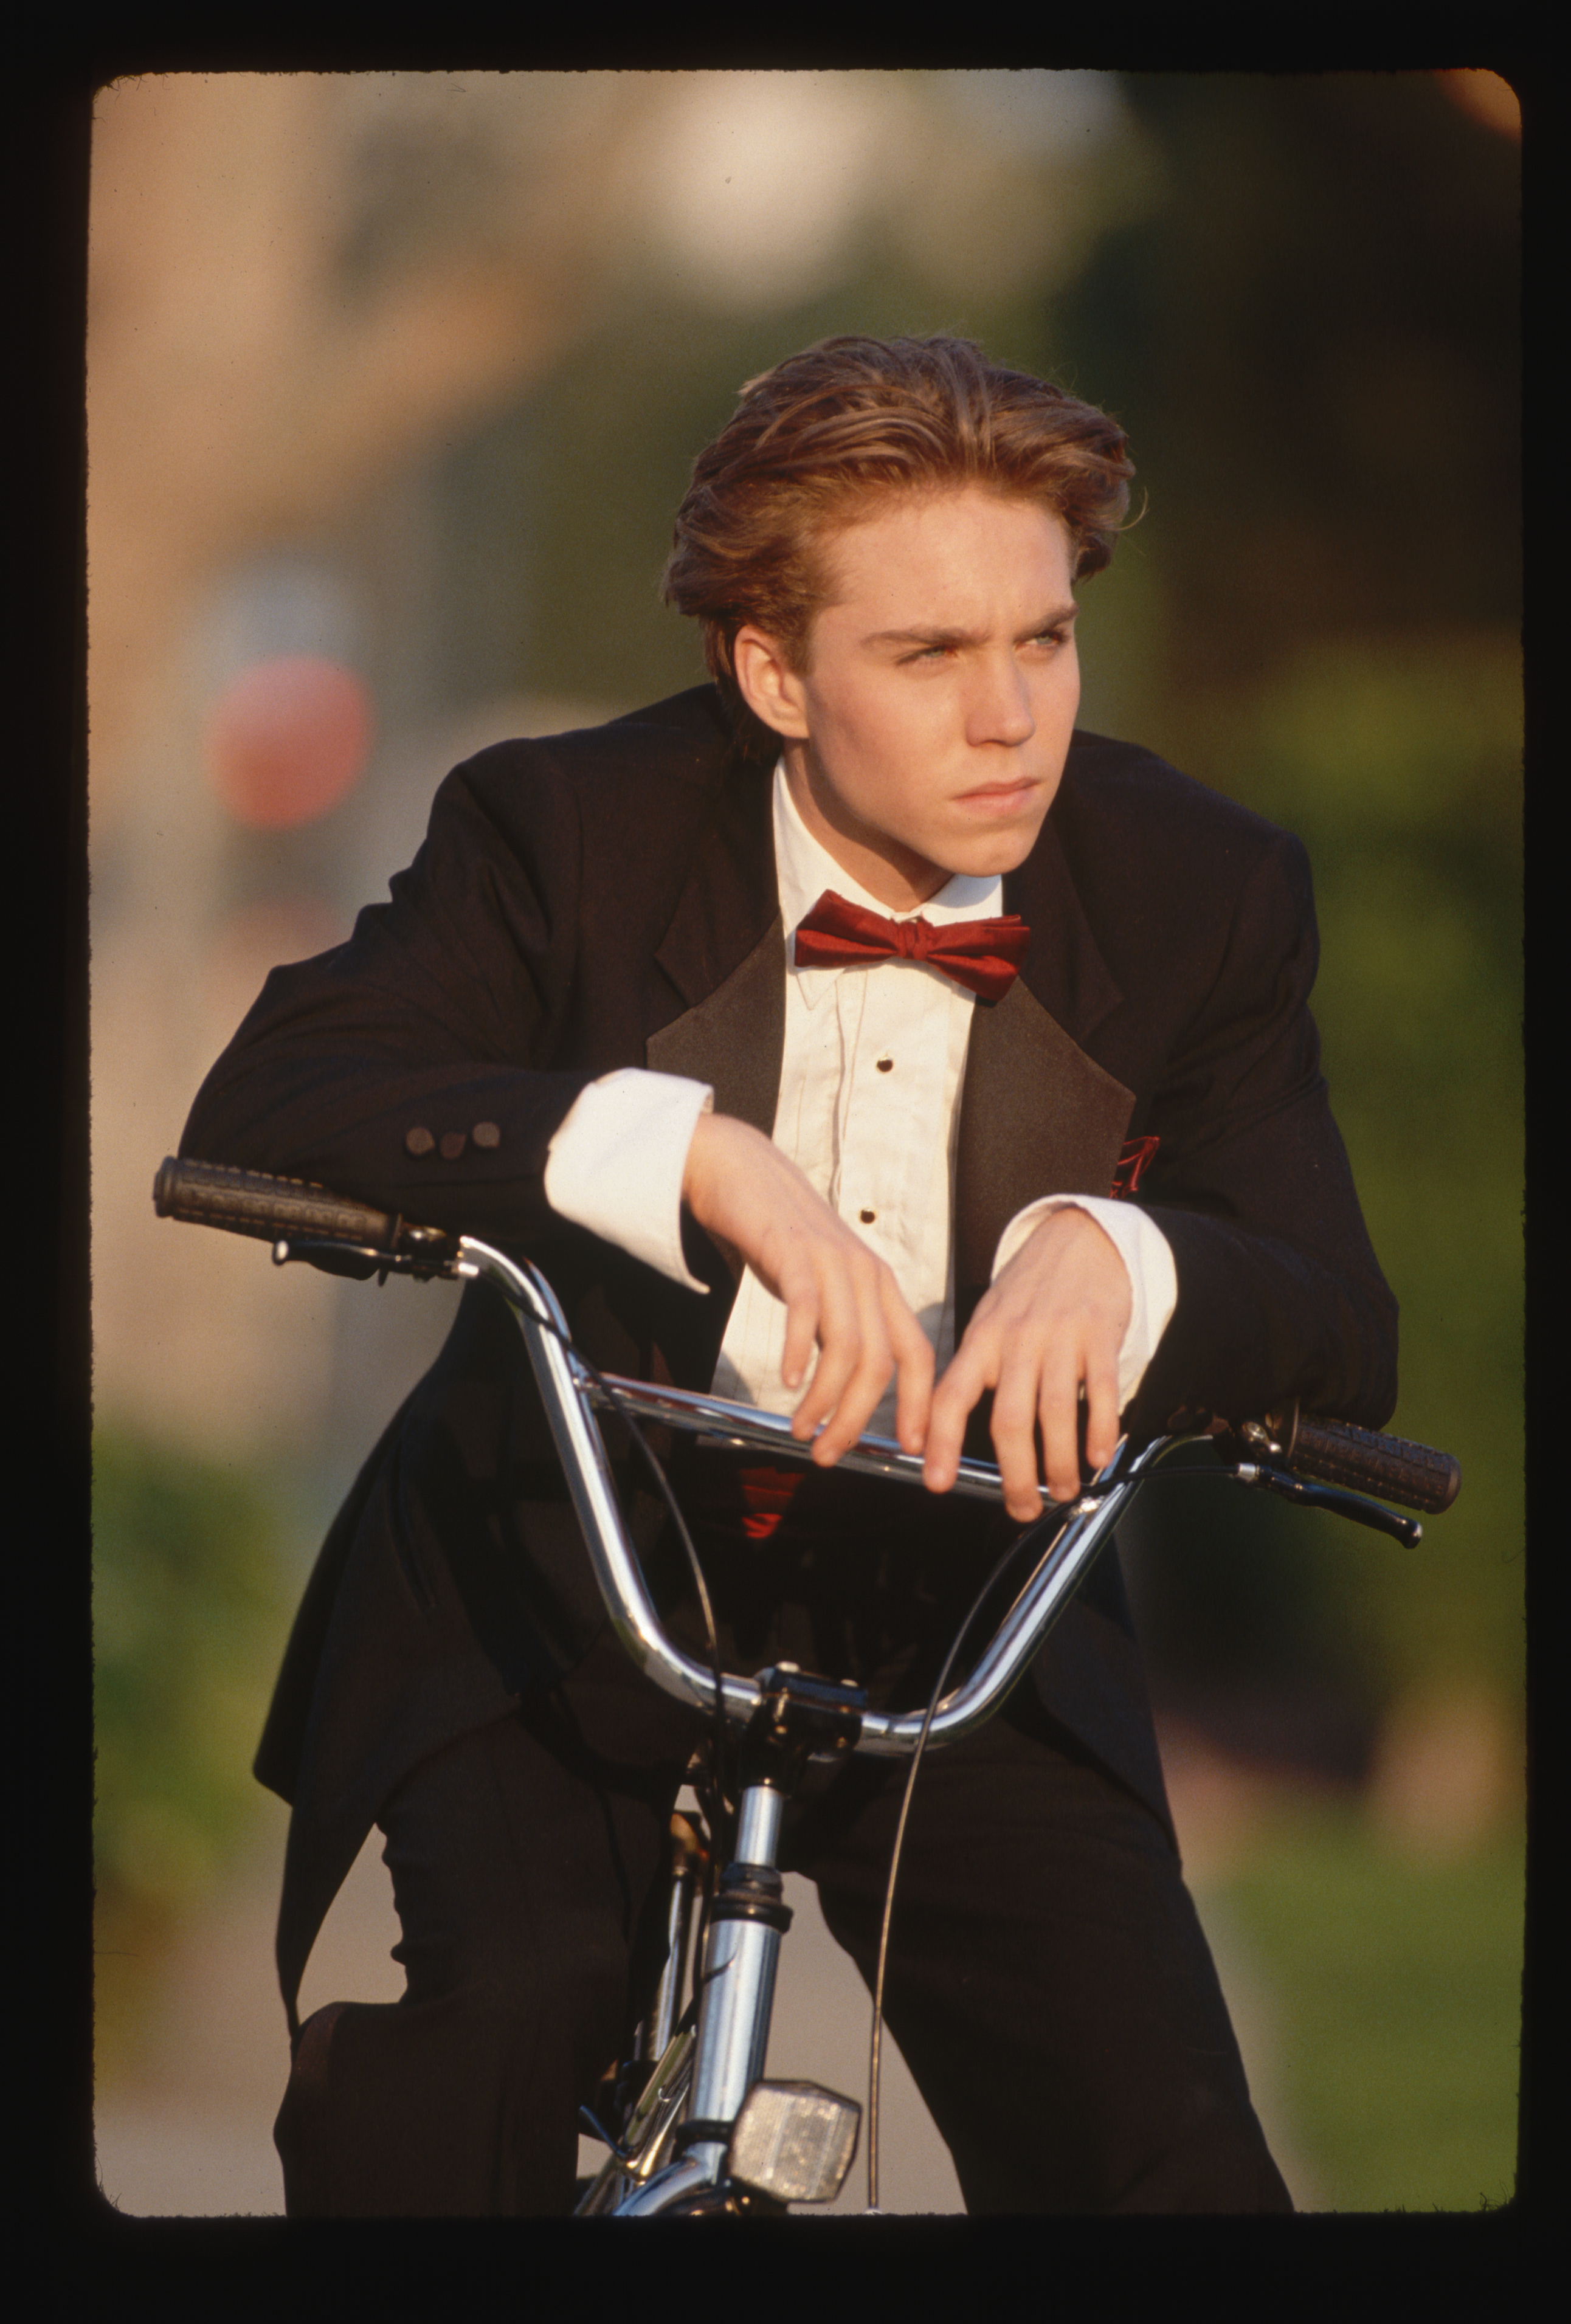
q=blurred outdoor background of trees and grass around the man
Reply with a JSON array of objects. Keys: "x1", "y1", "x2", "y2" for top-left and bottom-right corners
[{"x1": 88, "y1": 72, "x2": 1525, "y2": 2212}]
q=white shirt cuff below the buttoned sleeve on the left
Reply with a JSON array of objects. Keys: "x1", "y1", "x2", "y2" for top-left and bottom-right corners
[{"x1": 546, "y1": 1064, "x2": 714, "y2": 1292}]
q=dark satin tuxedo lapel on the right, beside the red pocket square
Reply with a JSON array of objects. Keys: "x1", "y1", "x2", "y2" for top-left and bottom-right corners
[{"x1": 955, "y1": 821, "x2": 1134, "y2": 1332}]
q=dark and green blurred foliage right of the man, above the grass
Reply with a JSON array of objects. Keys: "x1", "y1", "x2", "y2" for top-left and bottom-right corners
[{"x1": 1051, "y1": 72, "x2": 1525, "y2": 1729}]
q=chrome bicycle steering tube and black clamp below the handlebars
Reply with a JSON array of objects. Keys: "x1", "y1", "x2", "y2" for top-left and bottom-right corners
[{"x1": 681, "y1": 1664, "x2": 867, "y2": 2182}]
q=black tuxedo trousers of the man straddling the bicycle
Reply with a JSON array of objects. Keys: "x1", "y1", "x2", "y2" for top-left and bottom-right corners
[{"x1": 274, "y1": 1480, "x2": 1292, "y2": 2217}]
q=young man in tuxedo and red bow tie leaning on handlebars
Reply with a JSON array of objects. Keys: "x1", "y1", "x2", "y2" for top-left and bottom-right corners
[{"x1": 184, "y1": 339, "x2": 1394, "y2": 2215}]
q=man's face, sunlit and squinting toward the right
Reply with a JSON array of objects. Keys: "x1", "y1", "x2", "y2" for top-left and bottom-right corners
[{"x1": 737, "y1": 486, "x2": 1080, "y2": 911}]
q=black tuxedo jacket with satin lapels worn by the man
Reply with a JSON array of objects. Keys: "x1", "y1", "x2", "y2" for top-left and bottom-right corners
[{"x1": 181, "y1": 688, "x2": 1397, "y2": 2003}]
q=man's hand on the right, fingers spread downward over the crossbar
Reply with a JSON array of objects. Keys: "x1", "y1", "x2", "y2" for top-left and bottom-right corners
[{"x1": 925, "y1": 1209, "x2": 1132, "y2": 1525}]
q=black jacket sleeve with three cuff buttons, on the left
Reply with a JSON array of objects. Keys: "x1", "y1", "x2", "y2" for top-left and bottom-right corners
[{"x1": 181, "y1": 751, "x2": 595, "y2": 1243}]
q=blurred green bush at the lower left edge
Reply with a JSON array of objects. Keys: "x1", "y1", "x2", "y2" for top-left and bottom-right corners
[{"x1": 93, "y1": 1429, "x2": 295, "y2": 1924}]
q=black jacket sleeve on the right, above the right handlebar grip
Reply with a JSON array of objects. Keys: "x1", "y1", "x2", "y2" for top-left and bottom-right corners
[{"x1": 1115, "y1": 832, "x2": 1397, "y2": 1432}]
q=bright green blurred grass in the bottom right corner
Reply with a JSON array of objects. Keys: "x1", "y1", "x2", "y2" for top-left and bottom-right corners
[{"x1": 1201, "y1": 1805, "x2": 1525, "y2": 2212}]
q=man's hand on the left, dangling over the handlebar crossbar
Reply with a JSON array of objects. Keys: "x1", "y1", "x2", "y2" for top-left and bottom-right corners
[{"x1": 681, "y1": 1113, "x2": 932, "y2": 1469}]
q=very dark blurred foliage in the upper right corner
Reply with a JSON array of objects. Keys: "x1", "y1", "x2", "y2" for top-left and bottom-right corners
[{"x1": 1051, "y1": 72, "x2": 1522, "y2": 678}]
